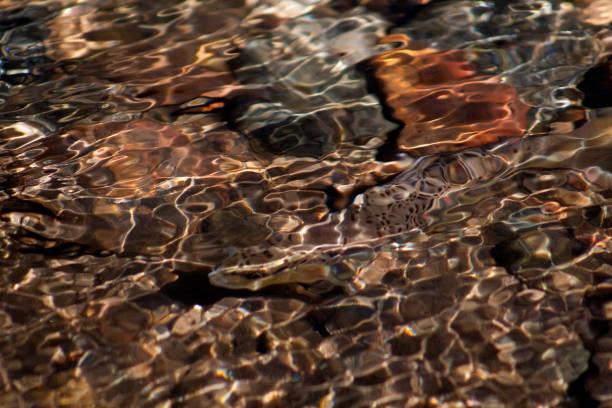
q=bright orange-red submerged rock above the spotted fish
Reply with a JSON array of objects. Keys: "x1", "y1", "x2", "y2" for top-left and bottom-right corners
[{"x1": 371, "y1": 35, "x2": 529, "y2": 156}]
